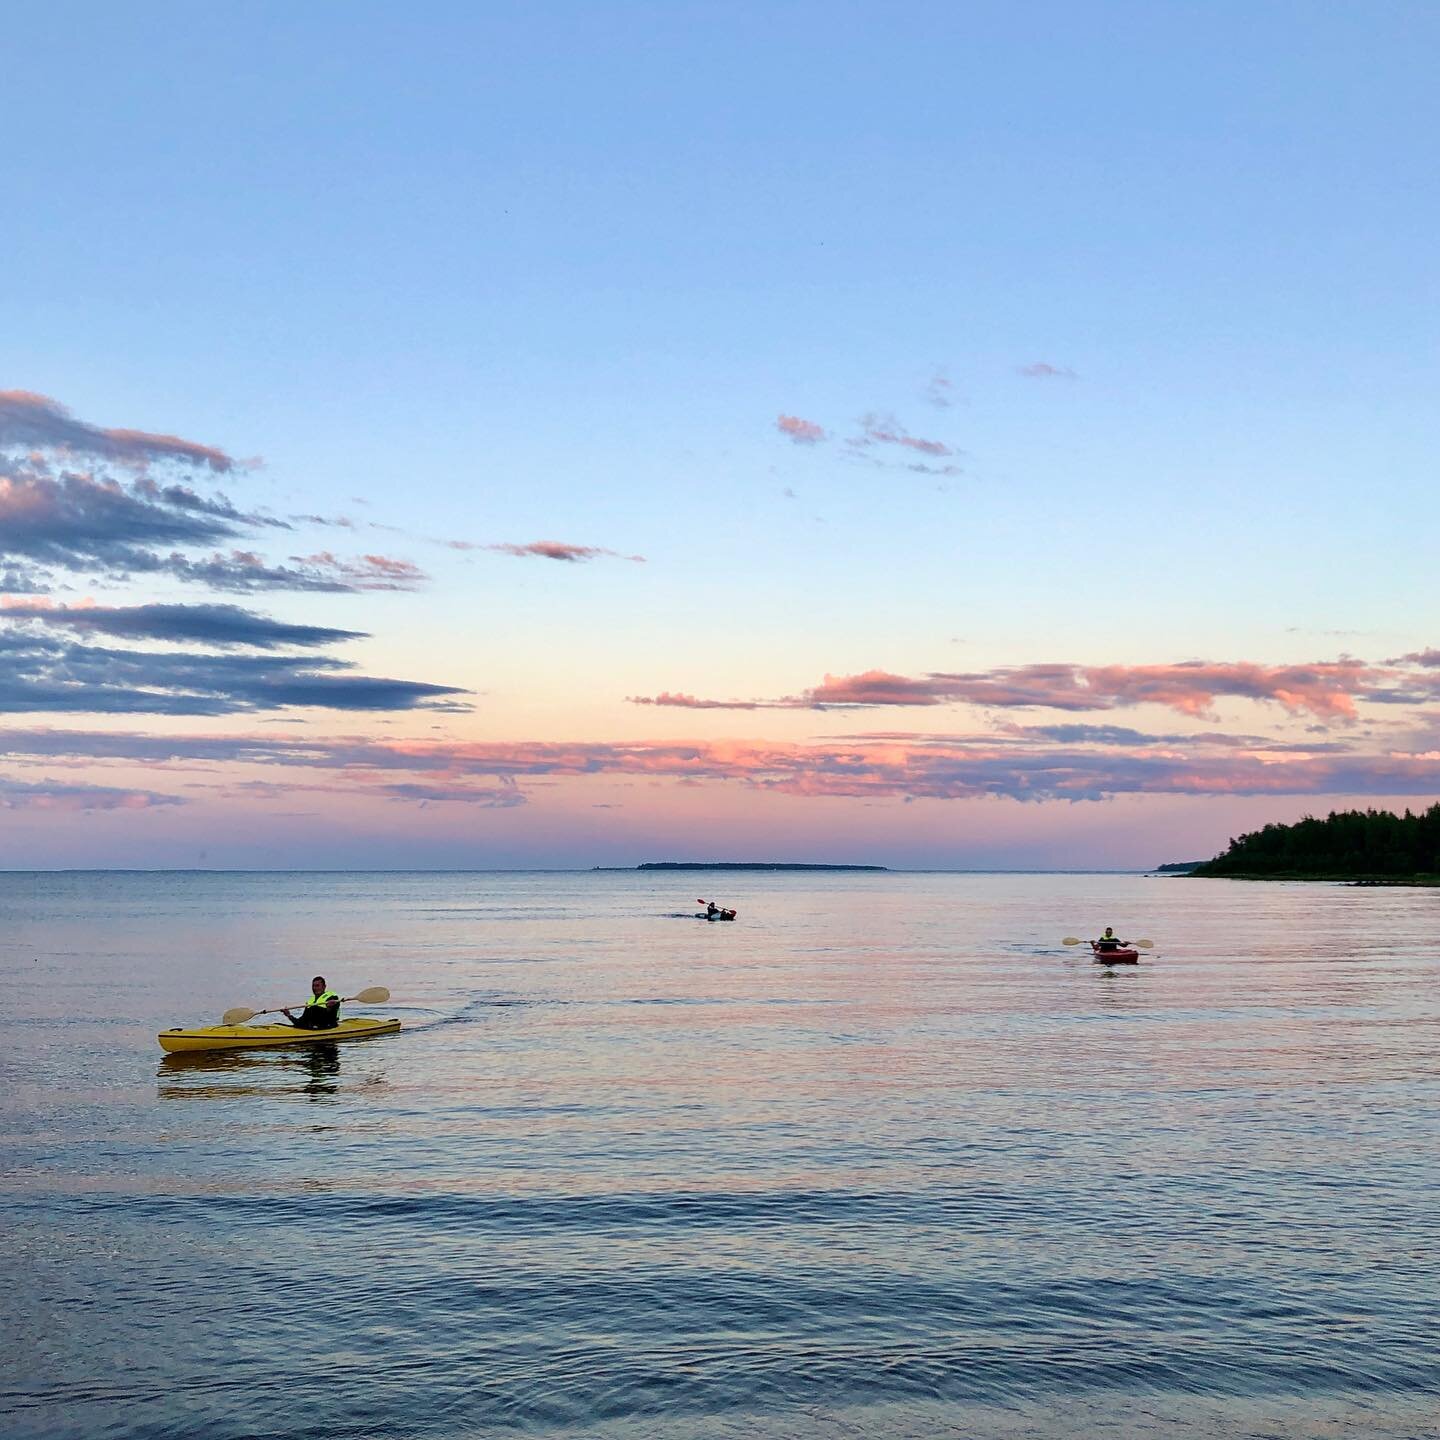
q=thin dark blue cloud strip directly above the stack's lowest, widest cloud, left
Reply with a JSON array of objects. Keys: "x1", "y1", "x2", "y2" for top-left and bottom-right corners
[{"x1": 0, "y1": 600, "x2": 366, "y2": 649}]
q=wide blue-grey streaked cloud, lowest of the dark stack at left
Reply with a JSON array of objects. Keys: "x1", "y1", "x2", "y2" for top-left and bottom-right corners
[{"x1": 0, "y1": 632, "x2": 464, "y2": 716}]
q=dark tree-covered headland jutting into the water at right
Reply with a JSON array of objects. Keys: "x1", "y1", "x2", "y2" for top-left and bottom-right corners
[{"x1": 1189, "y1": 804, "x2": 1440, "y2": 886}]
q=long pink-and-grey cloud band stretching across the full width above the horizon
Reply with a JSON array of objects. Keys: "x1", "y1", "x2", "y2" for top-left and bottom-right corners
[{"x1": 0, "y1": 730, "x2": 1440, "y2": 804}]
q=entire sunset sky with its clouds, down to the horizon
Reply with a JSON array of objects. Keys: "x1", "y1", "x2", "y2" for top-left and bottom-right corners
[{"x1": 0, "y1": 0, "x2": 1440, "y2": 870}]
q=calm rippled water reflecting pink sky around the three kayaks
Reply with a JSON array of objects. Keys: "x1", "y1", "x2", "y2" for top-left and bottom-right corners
[{"x1": 0, "y1": 874, "x2": 1440, "y2": 1440}]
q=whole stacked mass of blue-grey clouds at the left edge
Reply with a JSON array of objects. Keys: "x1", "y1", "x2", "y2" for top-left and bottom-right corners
[{"x1": 0, "y1": 392, "x2": 465, "y2": 731}]
